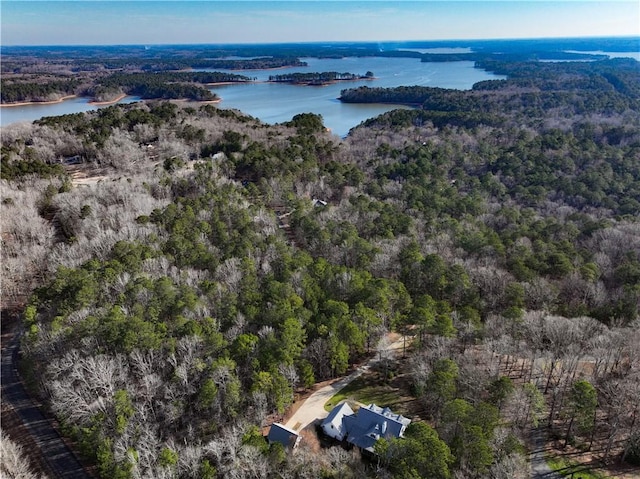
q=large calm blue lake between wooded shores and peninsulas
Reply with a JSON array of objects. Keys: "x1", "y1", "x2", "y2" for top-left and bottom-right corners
[{"x1": 0, "y1": 57, "x2": 505, "y2": 136}]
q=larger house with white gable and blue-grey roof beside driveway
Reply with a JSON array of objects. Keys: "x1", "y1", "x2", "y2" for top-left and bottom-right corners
[{"x1": 321, "y1": 403, "x2": 411, "y2": 452}]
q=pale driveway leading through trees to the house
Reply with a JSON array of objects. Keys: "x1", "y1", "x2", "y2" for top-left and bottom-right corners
[{"x1": 285, "y1": 337, "x2": 411, "y2": 431}]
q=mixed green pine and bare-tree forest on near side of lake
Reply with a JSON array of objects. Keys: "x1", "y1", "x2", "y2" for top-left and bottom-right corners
[{"x1": 0, "y1": 47, "x2": 640, "y2": 479}]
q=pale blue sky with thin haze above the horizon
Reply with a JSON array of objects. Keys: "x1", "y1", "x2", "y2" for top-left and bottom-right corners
[{"x1": 0, "y1": 0, "x2": 640, "y2": 45}]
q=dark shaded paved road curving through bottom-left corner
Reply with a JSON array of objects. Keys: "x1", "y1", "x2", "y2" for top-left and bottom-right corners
[{"x1": 0, "y1": 335, "x2": 92, "y2": 479}]
